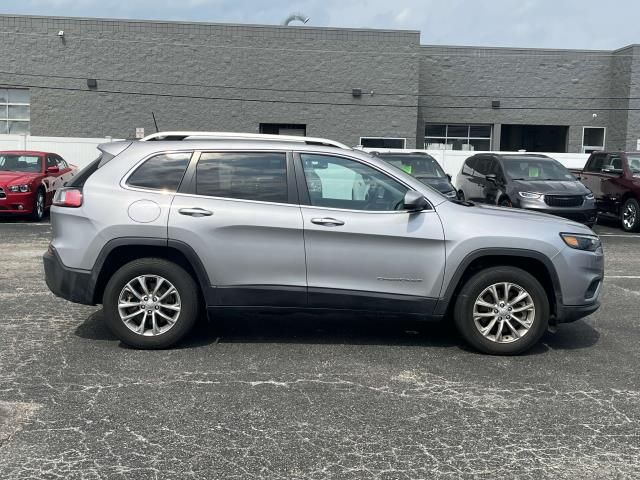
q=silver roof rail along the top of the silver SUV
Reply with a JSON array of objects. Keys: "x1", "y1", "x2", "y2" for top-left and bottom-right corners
[{"x1": 140, "y1": 132, "x2": 351, "y2": 150}]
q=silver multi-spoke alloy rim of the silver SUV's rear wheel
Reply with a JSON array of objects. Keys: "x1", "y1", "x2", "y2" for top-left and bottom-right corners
[{"x1": 118, "y1": 275, "x2": 182, "y2": 336}]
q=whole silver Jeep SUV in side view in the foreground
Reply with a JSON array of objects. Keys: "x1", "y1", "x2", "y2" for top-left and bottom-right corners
[{"x1": 44, "y1": 132, "x2": 604, "y2": 354}]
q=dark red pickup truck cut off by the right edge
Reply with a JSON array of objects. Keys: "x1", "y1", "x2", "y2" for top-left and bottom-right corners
[{"x1": 574, "y1": 152, "x2": 640, "y2": 232}]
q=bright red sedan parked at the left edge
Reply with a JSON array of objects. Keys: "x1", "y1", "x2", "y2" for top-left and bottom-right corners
[{"x1": 0, "y1": 150, "x2": 77, "y2": 220}]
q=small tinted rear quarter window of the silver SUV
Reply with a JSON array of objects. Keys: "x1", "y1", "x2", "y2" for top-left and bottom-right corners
[{"x1": 127, "y1": 153, "x2": 191, "y2": 192}]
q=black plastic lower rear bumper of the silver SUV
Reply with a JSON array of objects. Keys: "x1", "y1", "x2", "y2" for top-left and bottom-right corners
[{"x1": 43, "y1": 248, "x2": 95, "y2": 305}]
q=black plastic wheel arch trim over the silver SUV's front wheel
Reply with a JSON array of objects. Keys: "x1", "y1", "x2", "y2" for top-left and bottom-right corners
[{"x1": 435, "y1": 248, "x2": 562, "y2": 317}]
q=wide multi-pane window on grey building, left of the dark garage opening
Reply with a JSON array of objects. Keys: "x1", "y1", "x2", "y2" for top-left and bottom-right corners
[{"x1": 424, "y1": 123, "x2": 491, "y2": 151}]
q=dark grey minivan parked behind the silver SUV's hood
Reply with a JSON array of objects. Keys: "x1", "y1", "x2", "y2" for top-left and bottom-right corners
[{"x1": 456, "y1": 153, "x2": 597, "y2": 227}]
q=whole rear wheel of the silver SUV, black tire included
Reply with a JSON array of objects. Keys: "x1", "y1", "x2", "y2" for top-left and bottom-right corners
[{"x1": 103, "y1": 258, "x2": 199, "y2": 349}]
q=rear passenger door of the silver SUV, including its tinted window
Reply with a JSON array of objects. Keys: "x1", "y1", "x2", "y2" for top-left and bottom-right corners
[{"x1": 168, "y1": 150, "x2": 306, "y2": 306}]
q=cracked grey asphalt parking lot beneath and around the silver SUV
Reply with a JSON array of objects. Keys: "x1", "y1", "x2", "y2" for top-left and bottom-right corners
[{"x1": 0, "y1": 220, "x2": 640, "y2": 479}]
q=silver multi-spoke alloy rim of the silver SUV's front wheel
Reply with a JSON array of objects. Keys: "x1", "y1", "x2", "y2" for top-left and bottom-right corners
[{"x1": 473, "y1": 282, "x2": 536, "y2": 343}]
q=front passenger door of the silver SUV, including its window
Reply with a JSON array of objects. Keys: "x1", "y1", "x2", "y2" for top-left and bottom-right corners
[{"x1": 296, "y1": 153, "x2": 445, "y2": 314}]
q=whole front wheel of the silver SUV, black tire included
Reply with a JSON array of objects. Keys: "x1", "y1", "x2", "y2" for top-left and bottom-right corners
[{"x1": 454, "y1": 266, "x2": 549, "y2": 355}]
